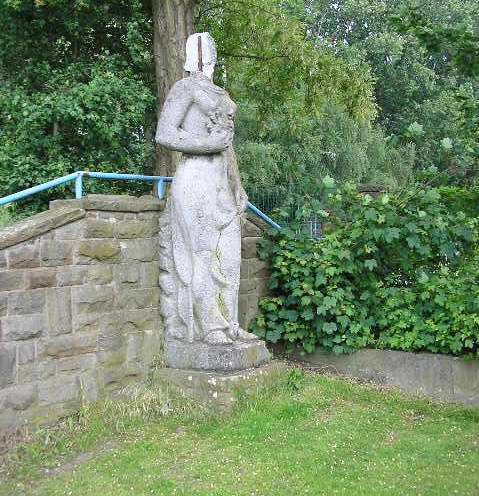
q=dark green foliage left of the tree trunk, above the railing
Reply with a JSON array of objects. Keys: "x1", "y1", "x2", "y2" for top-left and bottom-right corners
[{"x1": 0, "y1": 0, "x2": 155, "y2": 207}]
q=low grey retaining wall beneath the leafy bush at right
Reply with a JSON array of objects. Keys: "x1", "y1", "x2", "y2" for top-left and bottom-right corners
[{"x1": 296, "y1": 350, "x2": 479, "y2": 406}]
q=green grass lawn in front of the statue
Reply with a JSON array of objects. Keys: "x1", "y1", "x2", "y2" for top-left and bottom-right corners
[{"x1": 0, "y1": 371, "x2": 479, "y2": 496}]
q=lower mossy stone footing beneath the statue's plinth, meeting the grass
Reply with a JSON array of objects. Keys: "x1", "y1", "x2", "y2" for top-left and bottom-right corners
[{"x1": 156, "y1": 362, "x2": 285, "y2": 412}]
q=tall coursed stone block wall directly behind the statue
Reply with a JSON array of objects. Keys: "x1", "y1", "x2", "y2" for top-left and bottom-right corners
[{"x1": 0, "y1": 195, "x2": 267, "y2": 433}]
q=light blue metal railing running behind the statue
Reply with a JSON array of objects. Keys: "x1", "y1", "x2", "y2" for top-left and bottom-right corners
[{"x1": 0, "y1": 171, "x2": 281, "y2": 229}]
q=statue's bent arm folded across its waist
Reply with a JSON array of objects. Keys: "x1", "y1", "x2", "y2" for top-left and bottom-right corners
[{"x1": 155, "y1": 80, "x2": 232, "y2": 155}]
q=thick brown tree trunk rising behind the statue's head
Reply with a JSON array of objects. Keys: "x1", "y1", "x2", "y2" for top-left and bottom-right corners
[{"x1": 152, "y1": 0, "x2": 196, "y2": 176}]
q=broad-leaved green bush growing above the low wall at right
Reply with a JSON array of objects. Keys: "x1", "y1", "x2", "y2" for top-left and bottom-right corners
[{"x1": 252, "y1": 178, "x2": 479, "y2": 356}]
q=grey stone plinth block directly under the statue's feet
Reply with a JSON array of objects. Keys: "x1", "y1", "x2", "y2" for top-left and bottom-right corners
[{"x1": 165, "y1": 339, "x2": 270, "y2": 372}]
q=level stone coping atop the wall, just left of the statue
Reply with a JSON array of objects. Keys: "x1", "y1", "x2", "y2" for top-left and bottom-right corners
[{"x1": 50, "y1": 195, "x2": 165, "y2": 213}]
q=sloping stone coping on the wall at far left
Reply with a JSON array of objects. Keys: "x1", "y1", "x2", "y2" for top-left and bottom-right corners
[{"x1": 0, "y1": 206, "x2": 86, "y2": 250}]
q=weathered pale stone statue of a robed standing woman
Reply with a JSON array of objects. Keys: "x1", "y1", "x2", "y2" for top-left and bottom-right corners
[{"x1": 156, "y1": 33, "x2": 267, "y2": 368}]
